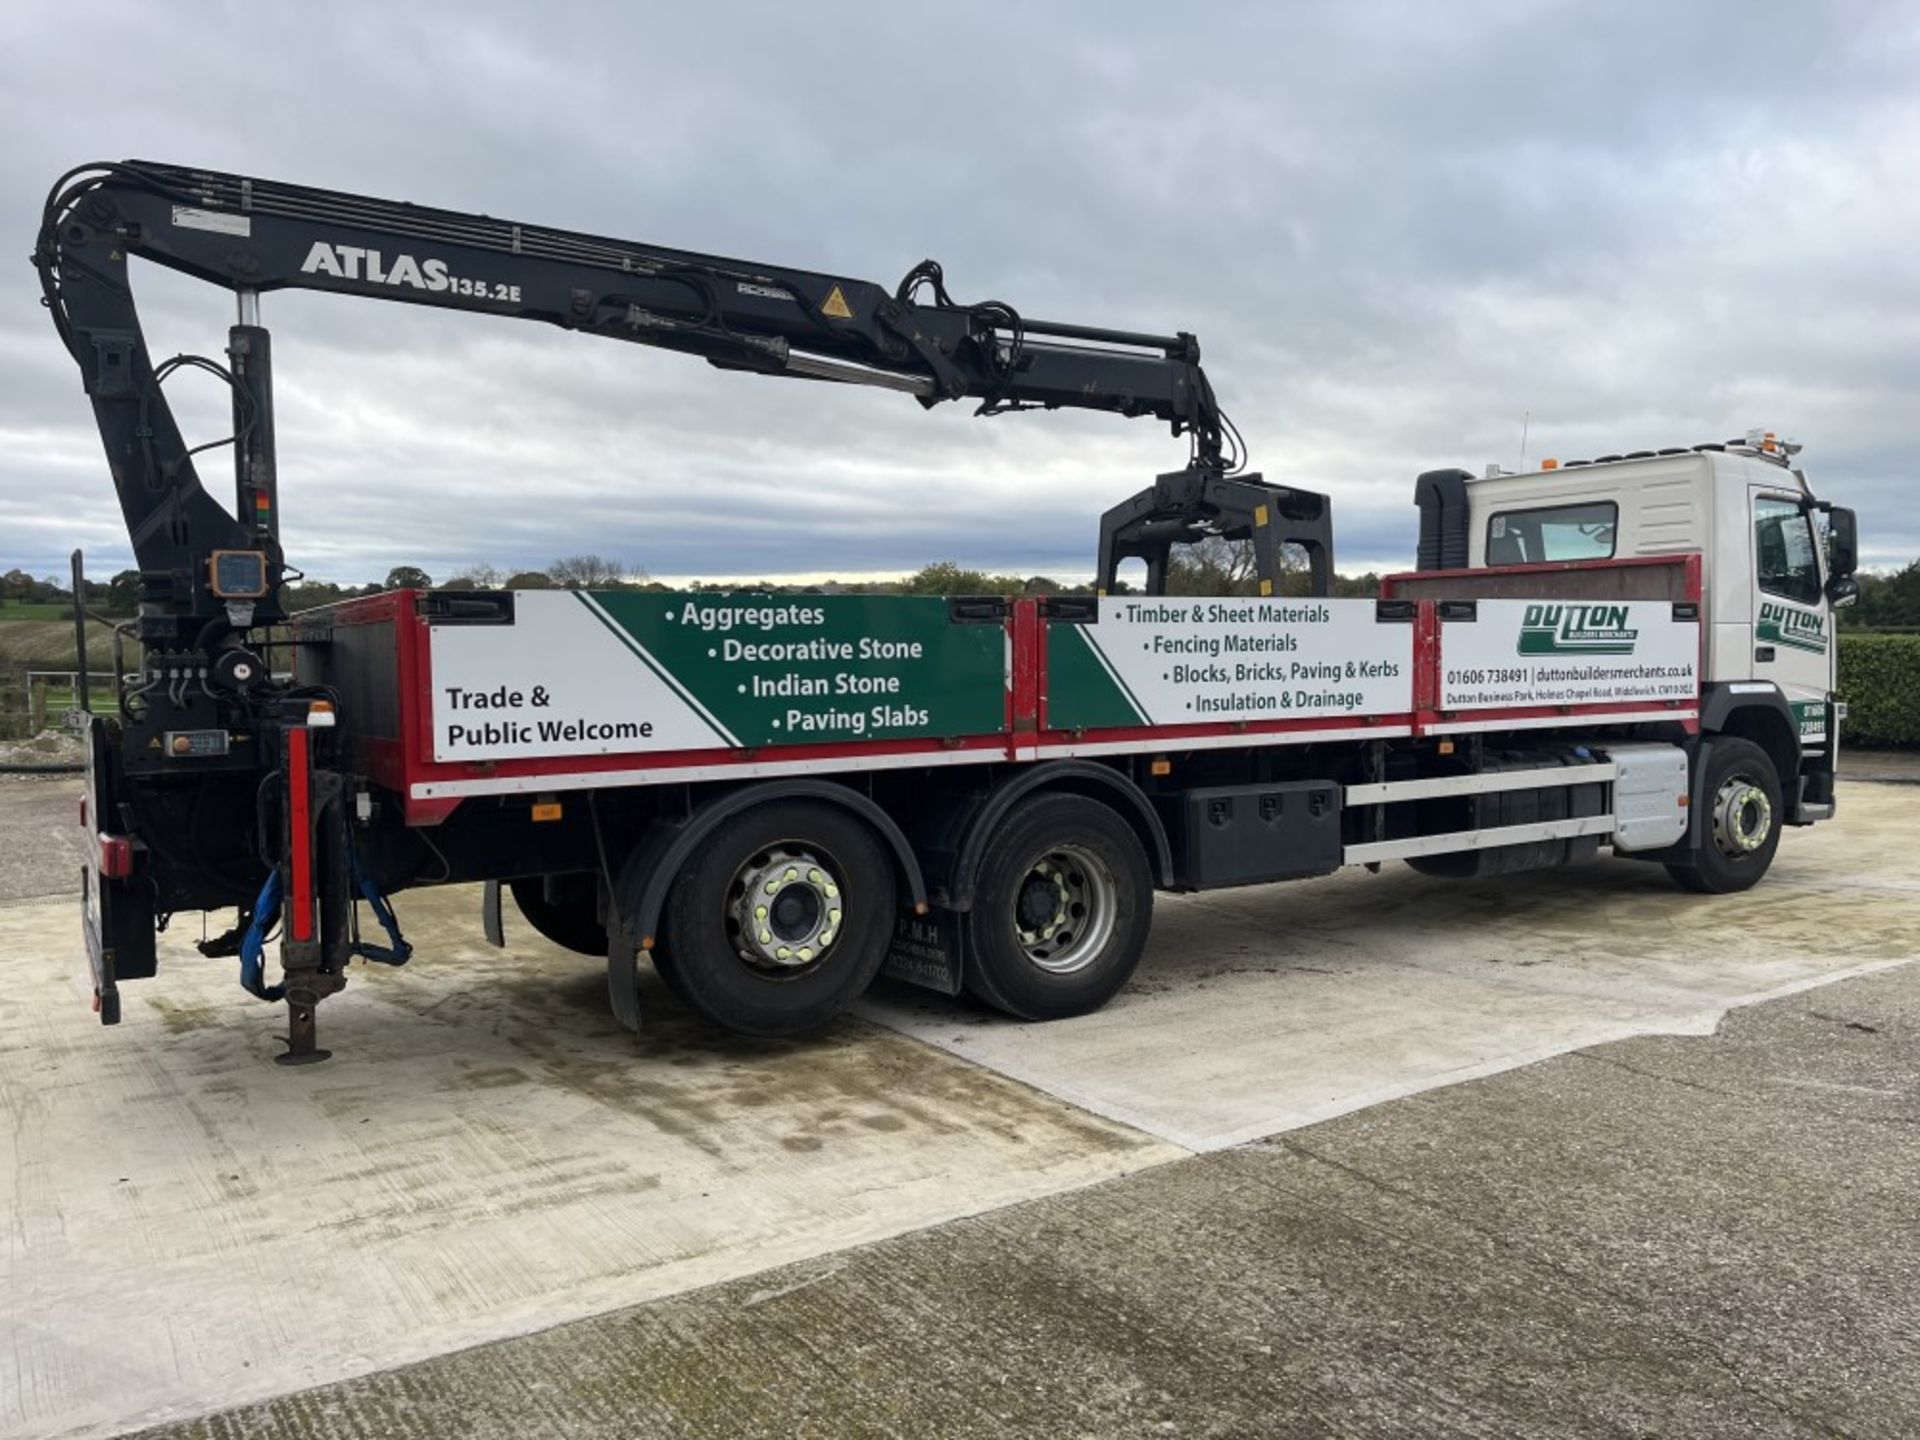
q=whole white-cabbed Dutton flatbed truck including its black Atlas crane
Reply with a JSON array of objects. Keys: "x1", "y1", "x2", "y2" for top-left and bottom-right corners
[{"x1": 35, "y1": 161, "x2": 1859, "y2": 1064}]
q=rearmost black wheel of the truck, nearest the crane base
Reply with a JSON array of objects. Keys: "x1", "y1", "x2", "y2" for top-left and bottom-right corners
[{"x1": 655, "y1": 801, "x2": 897, "y2": 1035}]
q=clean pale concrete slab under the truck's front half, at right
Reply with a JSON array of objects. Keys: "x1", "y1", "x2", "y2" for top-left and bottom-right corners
[{"x1": 862, "y1": 785, "x2": 1920, "y2": 1150}]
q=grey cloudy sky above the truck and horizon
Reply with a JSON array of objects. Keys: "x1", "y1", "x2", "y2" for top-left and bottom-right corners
[{"x1": 0, "y1": 0, "x2": 1920, "y2": 582}]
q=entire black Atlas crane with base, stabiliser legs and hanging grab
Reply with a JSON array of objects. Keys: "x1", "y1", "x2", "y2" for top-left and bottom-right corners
[{"x1": 33, "y1": 159, "x2": 1332, "y2": 1056}]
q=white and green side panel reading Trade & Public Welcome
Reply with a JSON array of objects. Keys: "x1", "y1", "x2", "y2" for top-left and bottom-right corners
[{"x1": 430, "y1": 591, "x2": 1006, "y2": 762}]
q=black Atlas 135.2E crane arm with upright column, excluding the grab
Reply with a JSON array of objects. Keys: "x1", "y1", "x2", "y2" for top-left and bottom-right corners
[{"x1": 35, "y1": 161, "x2": 1238, "y2": 647}]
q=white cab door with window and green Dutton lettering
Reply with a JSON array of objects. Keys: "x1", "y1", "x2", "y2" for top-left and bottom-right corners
[{"x1": 1749, "y1": 488, "x2": 1834, "y2": 745}]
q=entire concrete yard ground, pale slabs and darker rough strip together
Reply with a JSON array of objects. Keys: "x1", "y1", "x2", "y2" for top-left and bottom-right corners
[{"x1": 0, "y1": 783, "x2": 1920, "y2": 1436}]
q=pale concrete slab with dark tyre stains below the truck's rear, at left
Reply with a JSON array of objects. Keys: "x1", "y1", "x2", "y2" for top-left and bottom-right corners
[{"x1": 0, "y1": 891, "x2": 1179, "y2": 1434}]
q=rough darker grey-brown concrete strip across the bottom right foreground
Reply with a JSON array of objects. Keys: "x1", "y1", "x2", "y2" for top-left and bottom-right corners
[{"x1": 131, "y1": 966, "x2": 1920, "y2": 1440}]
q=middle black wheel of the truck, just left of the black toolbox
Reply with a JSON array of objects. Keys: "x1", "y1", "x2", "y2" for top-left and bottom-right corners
[{"x1": 966, "y1": 795, "x2": 1154, "y2": 1020}]
